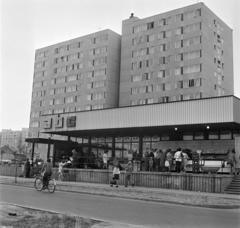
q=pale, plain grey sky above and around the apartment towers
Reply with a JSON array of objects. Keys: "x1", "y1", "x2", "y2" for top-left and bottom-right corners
[{"x1": 0, "y1": 0, "x2": 240, "y2": 131}]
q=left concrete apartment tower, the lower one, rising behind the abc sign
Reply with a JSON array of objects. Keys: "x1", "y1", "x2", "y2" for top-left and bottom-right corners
[{"x1": 30, "y1": 30, "x2": 121, "y2": 137}]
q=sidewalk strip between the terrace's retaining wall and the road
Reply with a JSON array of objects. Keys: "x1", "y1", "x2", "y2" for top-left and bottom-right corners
[{"x1": 0, "y1": 176, "x2": 240, "y2": 209}]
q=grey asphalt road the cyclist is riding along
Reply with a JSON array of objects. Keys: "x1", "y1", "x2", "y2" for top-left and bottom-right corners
[{"x1": 0, "y1": 185, "x2": 240, "y2": 228}]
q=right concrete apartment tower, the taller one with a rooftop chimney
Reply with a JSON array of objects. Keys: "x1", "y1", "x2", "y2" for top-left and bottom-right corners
[{"x1": 119, "y1": 3, "x2": 233, "y2": 106}]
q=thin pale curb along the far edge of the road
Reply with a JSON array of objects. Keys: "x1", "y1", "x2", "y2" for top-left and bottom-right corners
[{"x1": 0, "y1": 183, "x2": 240, "y2": 209}]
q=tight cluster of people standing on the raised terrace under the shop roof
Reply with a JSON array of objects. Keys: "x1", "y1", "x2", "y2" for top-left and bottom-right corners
[{"x1": 145, "y1": 148, "x2": 189, "y2": 172}]
